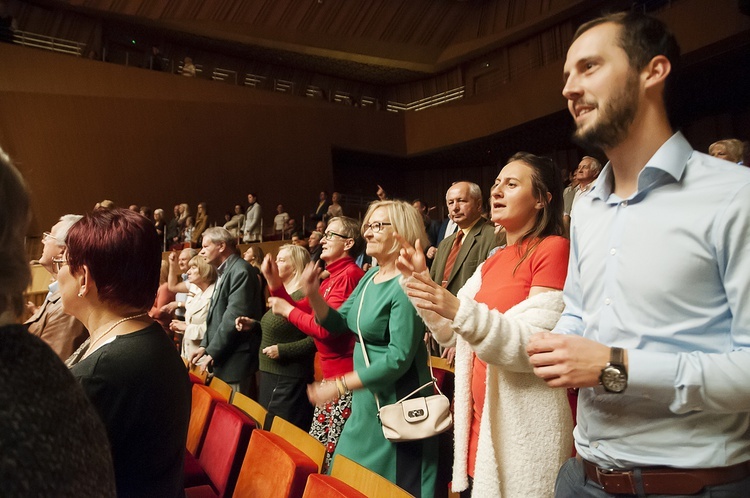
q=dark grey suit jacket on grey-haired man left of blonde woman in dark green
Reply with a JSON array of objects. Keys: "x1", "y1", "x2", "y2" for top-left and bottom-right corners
[{"x1": 201, "y1": 254, "x2": 263, "y2": 383}]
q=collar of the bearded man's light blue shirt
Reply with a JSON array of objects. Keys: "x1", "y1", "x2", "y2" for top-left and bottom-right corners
[{"x1": 591, "y1": 131, "x2": 693, "y2": 201}]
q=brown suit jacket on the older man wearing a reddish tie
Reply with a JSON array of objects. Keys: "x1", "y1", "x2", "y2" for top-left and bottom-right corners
[{"x1": 430, "y1": 218, "x2": 505, "y2": 295}]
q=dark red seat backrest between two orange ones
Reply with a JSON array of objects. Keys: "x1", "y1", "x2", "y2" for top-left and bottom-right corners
[{"x1": 198, "y1": 403, "x2": 255, "y2": 497}]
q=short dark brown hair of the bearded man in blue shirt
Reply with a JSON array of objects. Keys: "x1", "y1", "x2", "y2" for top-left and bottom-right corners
[{"x1": 573, "y1": 11, "x2": 680, "y2": 118}]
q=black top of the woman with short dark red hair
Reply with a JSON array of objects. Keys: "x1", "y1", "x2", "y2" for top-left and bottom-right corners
[{"x1": 71, "y1": 323, "x2": 191, "y2": 498}]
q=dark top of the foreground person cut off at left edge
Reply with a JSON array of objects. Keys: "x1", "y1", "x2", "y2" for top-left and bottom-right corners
[{"x1": 0, "y1": 325, "x2": 115, "y2": 497}]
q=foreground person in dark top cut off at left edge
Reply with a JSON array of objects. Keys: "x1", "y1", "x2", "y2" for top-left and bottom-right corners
[{"x1": 0, "y1": 148, "x2": 115, "y2": 497}]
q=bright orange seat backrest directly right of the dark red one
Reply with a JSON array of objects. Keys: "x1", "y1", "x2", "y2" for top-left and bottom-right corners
[{"x1": 234, "y1": 429, "x2": 318, "y2": 498}]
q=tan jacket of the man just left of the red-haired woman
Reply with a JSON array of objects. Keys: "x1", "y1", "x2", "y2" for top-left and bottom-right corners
[{"x1": 24, "y1": 291, "x2": 89, "y2": 361}]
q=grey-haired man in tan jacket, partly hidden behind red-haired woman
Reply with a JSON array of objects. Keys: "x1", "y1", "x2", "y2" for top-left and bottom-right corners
[{"x1": 25, "y1": 214, "x2": 89, "y2": 361}]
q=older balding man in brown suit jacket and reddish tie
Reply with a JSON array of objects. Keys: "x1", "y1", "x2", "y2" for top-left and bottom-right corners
[{"x1": 430, "y1": 182, "x2": 505, "y2": 295}]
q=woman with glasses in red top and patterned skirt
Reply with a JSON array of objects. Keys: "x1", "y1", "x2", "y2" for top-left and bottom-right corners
[{"x1": 268, "y1": 217, "x2": 365, "y2": 472}]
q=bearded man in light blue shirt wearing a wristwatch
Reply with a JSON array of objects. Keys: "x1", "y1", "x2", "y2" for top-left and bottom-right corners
[{"x1": 527, "y1": 11, "x2": 750, "y2": 497}]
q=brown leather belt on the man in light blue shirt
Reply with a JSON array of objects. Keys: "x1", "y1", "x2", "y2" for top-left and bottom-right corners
[{"x1": 583, "y1": 460, "x2": 750, "y2": 495}]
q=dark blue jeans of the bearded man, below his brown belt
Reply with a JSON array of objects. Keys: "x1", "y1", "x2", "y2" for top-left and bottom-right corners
[{"x1": 555, "y1": 458, "x2": 750, "y2": 498}]
